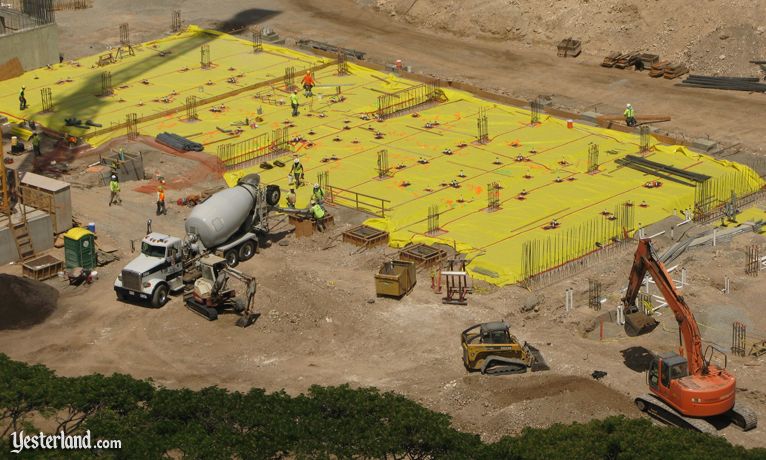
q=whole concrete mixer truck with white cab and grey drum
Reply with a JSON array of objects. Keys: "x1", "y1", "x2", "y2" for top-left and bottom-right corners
[{"x1": 114, "y1": 174, "x2": 283, "y2": 307}]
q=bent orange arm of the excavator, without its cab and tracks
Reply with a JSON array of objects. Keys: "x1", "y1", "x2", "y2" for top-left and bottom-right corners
[{"x1": 622, "y1": 238, "x2": 707, "y2": 375}]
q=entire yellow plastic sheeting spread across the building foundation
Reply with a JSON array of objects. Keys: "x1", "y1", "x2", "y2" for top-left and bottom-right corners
[{"x1": 0, "y1": 27, "x2": 764, "y2": 285}]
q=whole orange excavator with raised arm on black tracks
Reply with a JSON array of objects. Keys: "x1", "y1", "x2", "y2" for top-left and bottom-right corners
[{"x1": 622, "y1": 239, "x2": 757, "y2": 434}]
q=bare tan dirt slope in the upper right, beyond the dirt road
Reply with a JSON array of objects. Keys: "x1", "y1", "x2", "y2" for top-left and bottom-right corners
[{"x1": 370, "y1": 0, "x2": 766, "y2": 76}]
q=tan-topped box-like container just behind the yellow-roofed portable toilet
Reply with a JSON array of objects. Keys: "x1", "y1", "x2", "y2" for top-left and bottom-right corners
[{"x1": 19, "y1": 173, "x2": 72, "y2": 234}]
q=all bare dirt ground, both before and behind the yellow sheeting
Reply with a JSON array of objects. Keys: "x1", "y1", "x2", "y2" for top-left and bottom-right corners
[{"x1": 0, "y1": 0, "x2": 766, "y2": 447}]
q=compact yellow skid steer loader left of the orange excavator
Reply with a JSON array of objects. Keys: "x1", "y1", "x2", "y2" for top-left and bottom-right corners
[{"x1": 461, "y1": 322, "x2": 549, "y2": 375}]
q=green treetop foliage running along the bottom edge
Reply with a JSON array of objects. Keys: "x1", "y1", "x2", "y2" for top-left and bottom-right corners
[{"x1": 0, "y1": 354, "x2": 766, "y2": 460}]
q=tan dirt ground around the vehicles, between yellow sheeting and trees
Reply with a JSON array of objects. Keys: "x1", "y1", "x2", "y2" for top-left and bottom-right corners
[{"x1": 0, "y1": 144, "x2": 766, "y2": 446}]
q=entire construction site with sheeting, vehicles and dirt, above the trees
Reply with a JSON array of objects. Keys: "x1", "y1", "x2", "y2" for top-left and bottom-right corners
[{"x1": 0, "y1": 0, "x2": 766, "y2": 449}]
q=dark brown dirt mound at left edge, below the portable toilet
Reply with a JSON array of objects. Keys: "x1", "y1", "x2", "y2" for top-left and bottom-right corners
[{"x1": 0, "y1": 274, "x2": 59, "y2": 331}]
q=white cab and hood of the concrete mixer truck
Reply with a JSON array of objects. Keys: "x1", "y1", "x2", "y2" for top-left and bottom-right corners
[{"x1": 114, "y1": 232, "x2": 184, "y2": 307}]
